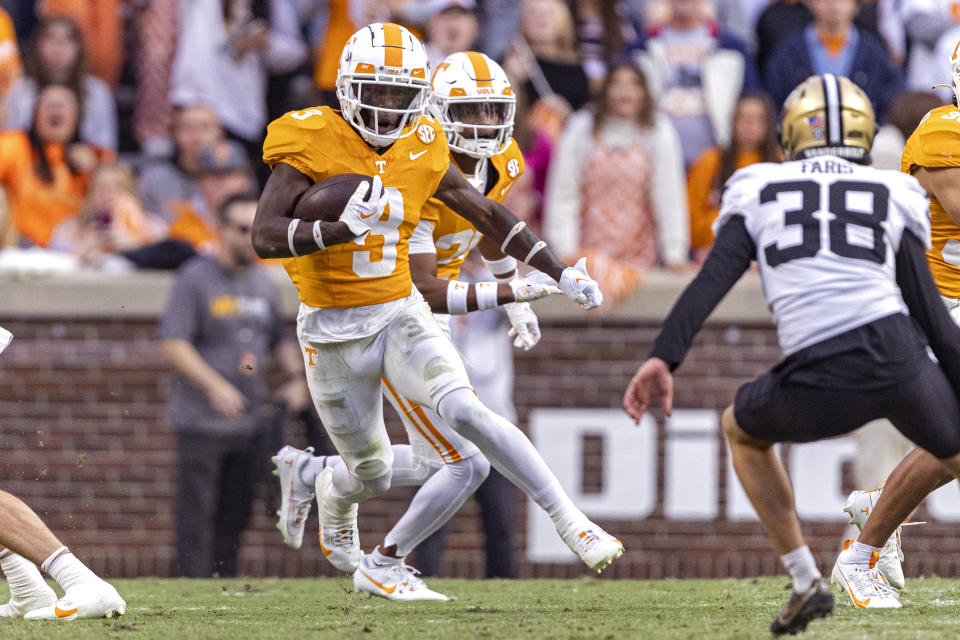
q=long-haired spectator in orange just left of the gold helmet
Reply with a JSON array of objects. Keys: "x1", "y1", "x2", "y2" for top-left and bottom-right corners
[{"x1": 687, "y1": 92, "x2": 780, "y2": 263}]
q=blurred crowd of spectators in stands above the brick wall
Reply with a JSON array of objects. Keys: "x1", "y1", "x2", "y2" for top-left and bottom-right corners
[{"x1": 0, "y1": 0, "x2": 960, "y2": 299}]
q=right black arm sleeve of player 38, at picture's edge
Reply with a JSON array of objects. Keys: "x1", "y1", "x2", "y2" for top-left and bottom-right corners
[{"x1": 897, "y1": 230, "x2": 960, "y2": 390}]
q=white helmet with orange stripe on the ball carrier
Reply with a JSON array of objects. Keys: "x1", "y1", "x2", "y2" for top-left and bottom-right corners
[{"x1": 337, "y1": 22, "x2": 430, "y2": 147}]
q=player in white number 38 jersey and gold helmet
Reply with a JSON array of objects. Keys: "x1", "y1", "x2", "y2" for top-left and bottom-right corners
[{"x1": 623, "y1": 74, "x2": 960, "y2": 634}]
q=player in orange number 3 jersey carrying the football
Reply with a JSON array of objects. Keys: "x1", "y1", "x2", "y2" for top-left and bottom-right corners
[{"x1": 254, "y1": 23, "x2": 623, "y2": 593}]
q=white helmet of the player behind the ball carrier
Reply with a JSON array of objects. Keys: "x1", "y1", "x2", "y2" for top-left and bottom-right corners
[{"x1": 430, "y1": 51, "x2": 517, "y2": 158}]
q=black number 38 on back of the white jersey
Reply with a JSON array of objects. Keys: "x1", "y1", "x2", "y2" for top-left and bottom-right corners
[{"x1": 760, "y1": 180, "x2": 890, "y2": 267}]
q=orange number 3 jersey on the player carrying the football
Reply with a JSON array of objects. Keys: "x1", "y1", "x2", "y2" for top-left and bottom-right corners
[{"x1": 263, "y1": 107, "x2": 450, "y2": 309}]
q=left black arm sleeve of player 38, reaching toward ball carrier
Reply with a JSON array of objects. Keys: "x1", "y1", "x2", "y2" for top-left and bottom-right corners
[{"x1": 650, "y1": 215, "x2": 756, "y2": 371}]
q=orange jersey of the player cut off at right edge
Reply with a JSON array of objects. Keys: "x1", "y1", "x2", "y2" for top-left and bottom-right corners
[{"x1": 900, "y1": 105, "x2": 960, "y2": 298}]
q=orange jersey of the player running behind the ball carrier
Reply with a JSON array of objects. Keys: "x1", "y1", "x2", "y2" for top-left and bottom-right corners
[{"x1": 420, "y1": 138, "x2": 523, "y2": 280}]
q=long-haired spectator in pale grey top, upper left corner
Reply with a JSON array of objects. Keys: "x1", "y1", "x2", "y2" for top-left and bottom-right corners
[{"x1": 6, "y1": 16, "x2": 117, "y2": 149}]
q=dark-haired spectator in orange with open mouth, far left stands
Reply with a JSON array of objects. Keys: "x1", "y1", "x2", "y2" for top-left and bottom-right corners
[{"x1": 0, "y1": 85, "x2": 113, "y2": 247}]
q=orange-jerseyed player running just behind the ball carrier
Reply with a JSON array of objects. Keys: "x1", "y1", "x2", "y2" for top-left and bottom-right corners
[{"x1": 273, "y1": 51, "x2": 559, "y2": 600}]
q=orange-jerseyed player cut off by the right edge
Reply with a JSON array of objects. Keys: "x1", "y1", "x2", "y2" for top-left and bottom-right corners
[{"x1": 833, "y1": 42, "x2": 960, "y2": 606}]
